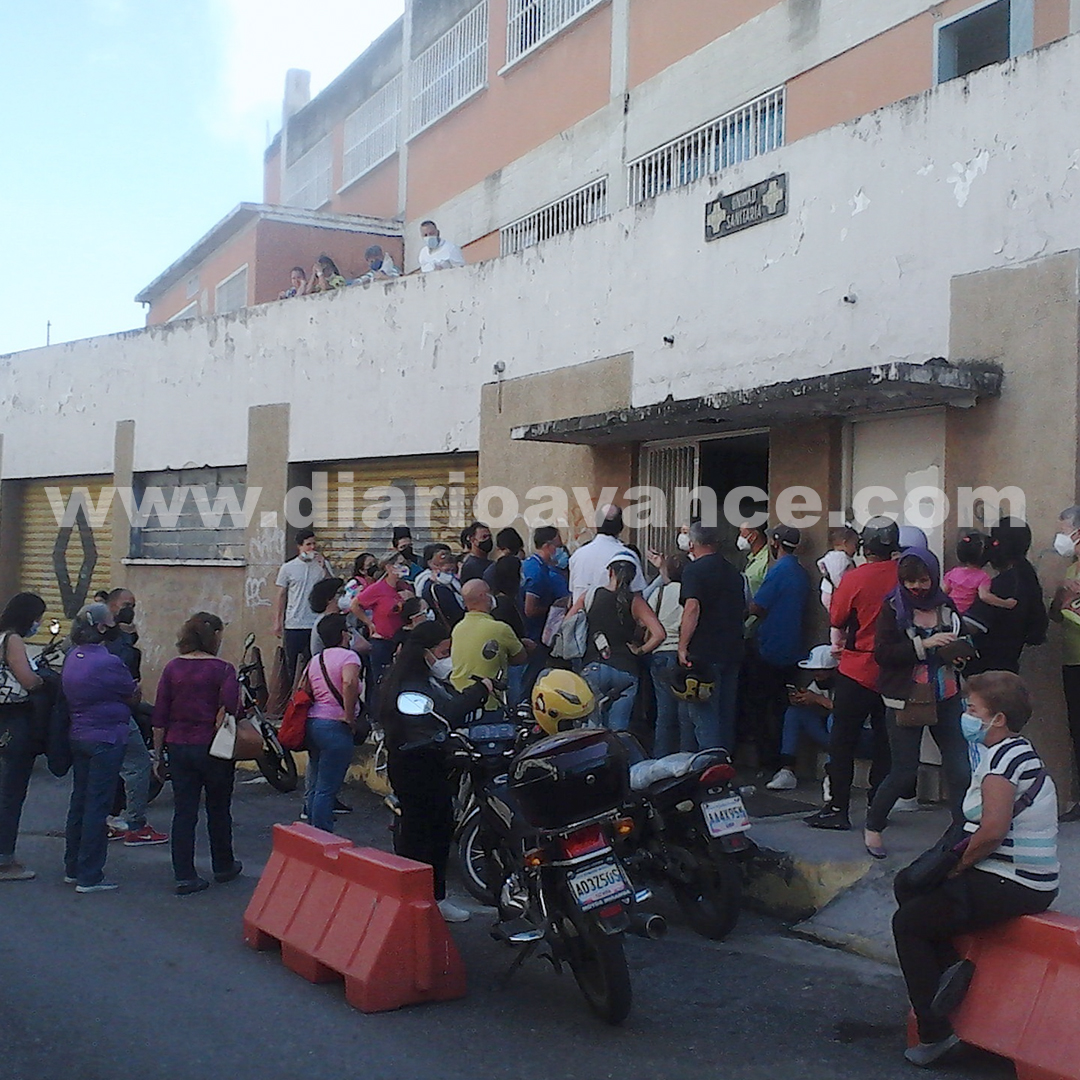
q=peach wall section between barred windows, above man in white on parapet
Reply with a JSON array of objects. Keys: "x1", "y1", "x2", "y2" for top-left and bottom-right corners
[{"x1": 405, "y1": 0, "x2": 611, "y2": 225}]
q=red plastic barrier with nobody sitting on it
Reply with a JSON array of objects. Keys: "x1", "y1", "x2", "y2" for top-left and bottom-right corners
[{"x1": 244, "y1": 824, "x2": 465, "y2": 1012}]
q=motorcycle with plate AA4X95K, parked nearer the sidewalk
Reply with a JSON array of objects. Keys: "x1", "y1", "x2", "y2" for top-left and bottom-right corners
[{"x1": 617, "y1": 735, "x2": 756, "y2": 941}]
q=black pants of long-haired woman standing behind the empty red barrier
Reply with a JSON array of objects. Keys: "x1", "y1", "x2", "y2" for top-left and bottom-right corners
[{"x1": 387, "y1": 750, "x2": 454, "y2": 900}]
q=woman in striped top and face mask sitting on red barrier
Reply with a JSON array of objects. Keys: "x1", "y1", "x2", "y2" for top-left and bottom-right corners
[{"x1": 892, "y1": 672, "x2": 1058, "y2": 1067}]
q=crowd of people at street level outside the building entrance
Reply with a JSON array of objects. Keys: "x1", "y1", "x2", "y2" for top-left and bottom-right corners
[{"x1": 0, "y1": 505, "x2": 1080, "y2": 1064}]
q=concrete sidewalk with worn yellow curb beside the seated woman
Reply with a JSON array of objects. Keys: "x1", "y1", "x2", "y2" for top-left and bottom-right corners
[{"x1": 746, "y1": 788, "x2": 1080, "y2": 964}]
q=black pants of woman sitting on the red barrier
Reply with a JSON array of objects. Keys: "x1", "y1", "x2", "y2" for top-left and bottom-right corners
[{"x1": 892, "y1": 868, "x2": 1057, "y2": 1042}]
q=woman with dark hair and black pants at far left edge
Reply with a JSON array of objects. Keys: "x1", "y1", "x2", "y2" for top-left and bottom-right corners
[{"x1": 0, "y1": 593, "x2": 45, "y2": 881}]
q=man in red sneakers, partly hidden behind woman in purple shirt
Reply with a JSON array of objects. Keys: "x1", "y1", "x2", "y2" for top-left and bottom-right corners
[{"x1": 102, "y1": 589, "x2": 168, "y2": 848}]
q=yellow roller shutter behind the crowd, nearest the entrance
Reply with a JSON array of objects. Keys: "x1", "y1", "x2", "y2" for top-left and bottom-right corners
[{"x1": 315, "y1": 454, "x2": 478, "y2": 571}]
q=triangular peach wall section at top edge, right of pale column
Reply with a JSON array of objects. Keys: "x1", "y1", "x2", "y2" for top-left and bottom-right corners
[{"x1": 630, "y1": 0, "x2": 780, "y2": 87}]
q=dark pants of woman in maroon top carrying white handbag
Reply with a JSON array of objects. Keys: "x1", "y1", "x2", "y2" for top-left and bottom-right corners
[{"x1": 168, "y1": 743, "x2": 235, "y2": 881}]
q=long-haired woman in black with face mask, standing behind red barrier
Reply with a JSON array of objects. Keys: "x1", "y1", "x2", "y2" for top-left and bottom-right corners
[{"x1": 379, "y1": 622, "x2": 492, "y2": 922}]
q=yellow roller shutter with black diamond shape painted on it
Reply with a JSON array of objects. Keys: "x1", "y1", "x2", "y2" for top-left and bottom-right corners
[{"x1": 18, "y1": 476, "x2": 112, "y2": 639}]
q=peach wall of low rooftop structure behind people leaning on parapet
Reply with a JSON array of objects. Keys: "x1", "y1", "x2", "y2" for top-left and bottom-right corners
[{"x1": 252, "y1": 221, "x2": 402, "y2": 303}]
